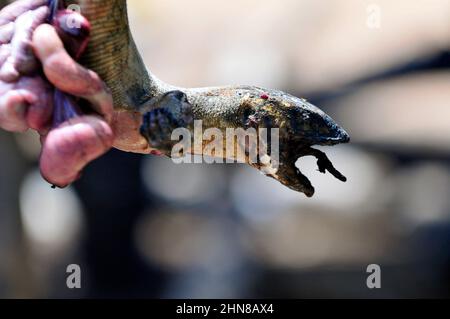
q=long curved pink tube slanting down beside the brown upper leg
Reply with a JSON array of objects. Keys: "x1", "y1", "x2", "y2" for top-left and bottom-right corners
[{"x1": 33, "y1": 24, "x2": 113, "y2": 122}]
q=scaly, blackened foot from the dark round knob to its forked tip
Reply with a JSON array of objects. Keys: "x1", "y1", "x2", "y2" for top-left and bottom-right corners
[{"x1": 141, "y1": 86, "x2": 350, "y2": 197}]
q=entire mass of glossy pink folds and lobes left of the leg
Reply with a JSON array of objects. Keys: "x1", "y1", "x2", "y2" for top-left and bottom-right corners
[{"x1": 0, "y1": 0, "x2": 114, "y2": 187}]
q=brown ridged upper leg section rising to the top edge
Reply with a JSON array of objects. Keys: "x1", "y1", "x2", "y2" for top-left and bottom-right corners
[{"x1": 71, "y1": 0, "x2": 174, "y2": 110}]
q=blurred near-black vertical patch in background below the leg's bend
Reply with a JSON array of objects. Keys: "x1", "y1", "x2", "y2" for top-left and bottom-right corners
[{"x1": 75, "y1": 150, "x2": 165, "y2": 298}]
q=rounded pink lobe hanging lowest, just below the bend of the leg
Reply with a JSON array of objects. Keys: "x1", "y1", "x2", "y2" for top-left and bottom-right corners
[{"x1": 40, "y1": 116, "x2": 114, "y2": 187}]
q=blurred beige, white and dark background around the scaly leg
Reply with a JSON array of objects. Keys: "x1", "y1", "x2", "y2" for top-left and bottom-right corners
[{"x1": 0, "y1": 0, "x2": 450, "y2": 298}]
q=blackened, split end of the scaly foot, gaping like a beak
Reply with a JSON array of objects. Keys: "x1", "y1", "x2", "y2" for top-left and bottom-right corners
[{"x1": 229, "y1": 87, "x2": 350, "y2": 197}]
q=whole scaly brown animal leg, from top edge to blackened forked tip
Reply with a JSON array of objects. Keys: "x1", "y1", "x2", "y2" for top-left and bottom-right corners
[{"x1": 72, "y1": 0, "x2": 350, "y2": 196}]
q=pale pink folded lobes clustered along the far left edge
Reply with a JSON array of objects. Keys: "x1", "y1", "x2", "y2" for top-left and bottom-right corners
[{"x1": 0, "y1": 0, "x2": 52, "y2": 132}]
